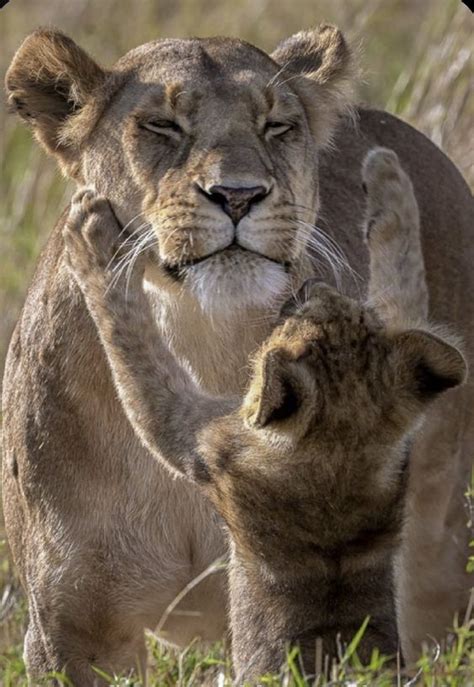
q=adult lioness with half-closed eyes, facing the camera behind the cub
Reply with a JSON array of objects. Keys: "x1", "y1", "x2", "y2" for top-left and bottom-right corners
[{"x1": 3, "y1": 20, "x2": 474, "y2": 685}]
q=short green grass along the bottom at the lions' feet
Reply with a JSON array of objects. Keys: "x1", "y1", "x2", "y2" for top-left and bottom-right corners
[{"x1": 0, "y1": 622, "x2": 474, "y2": 687}]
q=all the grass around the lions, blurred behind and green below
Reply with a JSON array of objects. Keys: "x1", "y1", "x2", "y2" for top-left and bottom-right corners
[{"x1": 0, "y1": 0, "x2": 474, "y2": 687}]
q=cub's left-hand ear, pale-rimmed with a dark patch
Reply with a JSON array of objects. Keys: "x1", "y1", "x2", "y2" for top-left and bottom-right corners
[{"x1": 242, "y1": 349, "x2": 308, "y2": 428}]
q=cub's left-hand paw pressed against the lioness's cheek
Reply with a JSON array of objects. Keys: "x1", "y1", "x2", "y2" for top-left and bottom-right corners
[{"x1": 63, "y1": 188, "x2": 143, "y2": 292}]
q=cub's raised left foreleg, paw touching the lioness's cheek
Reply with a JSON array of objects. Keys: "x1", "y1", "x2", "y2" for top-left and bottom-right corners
[{"x1": 64, "y1": 189, "x2": 232, "y2": 476}]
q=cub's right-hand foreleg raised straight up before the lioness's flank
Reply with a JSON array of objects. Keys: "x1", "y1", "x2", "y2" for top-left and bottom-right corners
[{"x1": 362, "y1": 148, "x2": 428, "y2": 326}]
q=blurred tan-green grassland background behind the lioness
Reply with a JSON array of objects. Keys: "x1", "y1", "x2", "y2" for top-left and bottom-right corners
[{"x1": 0, "y1": 0, "x2": 474, "y2": 668}]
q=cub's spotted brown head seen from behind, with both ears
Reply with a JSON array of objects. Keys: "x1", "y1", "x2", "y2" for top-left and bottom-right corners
[{"x1": 241, "y1": 280, "x2": 466, "y2": 456}]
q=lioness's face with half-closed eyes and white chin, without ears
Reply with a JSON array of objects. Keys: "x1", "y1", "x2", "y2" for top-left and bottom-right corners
[{"x1": 84, "y1": 40, "x2": 318, "y2": 311}]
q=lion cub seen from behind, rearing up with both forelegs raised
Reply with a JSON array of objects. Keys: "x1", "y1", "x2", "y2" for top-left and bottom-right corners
[{"x1": 65, "y1": 150, "x2": 466, "y2": 682}]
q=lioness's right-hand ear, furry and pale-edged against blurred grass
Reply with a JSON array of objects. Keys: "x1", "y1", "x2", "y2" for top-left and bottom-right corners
[{"x1": 271, "y1": 24, "x2": 357, "y2": 145}]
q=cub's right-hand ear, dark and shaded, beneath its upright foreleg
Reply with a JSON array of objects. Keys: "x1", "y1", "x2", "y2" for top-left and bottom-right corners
[{"x1": 396, "y1": 329, "x2": 467, "y2": 402}]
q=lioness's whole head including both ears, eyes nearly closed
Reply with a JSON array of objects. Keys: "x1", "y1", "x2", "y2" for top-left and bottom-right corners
[{"x1": 6, "y1": 26, "x2": 353, "y2": 310}]
